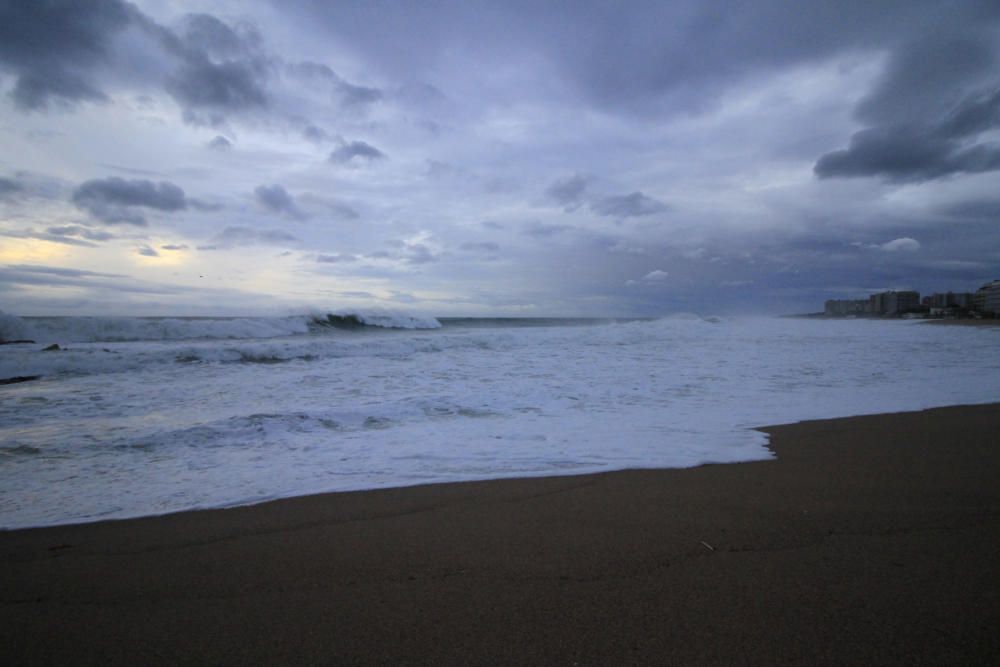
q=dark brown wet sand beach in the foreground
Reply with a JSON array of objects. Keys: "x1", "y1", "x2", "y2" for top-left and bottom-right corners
[{"x1": 0, "y1": 405, "x2": 1000, "y2": 665}]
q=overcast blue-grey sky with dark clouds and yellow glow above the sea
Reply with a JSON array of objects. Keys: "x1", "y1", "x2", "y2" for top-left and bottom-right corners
[{"x1": 0, "y1": 0, "x2": 1000, "y2": 316}]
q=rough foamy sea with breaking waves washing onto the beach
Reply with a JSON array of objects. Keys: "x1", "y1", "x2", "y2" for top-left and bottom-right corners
[{"x1": 0, "y1": 311, "x2": 1000, "y2": 529}]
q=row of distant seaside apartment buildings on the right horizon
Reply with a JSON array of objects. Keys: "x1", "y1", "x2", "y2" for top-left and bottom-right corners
[{"x1": 823, "y1": 280, "x2": 1000, "y2": 317}]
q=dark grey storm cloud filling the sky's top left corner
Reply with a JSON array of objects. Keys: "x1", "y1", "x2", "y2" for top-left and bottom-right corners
[{"x1": 0, "y1": 0, "x2": 134, "y2": 110}]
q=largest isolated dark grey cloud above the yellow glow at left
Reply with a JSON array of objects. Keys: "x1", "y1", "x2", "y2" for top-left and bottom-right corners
[{"x1": 73, "y1": 176, "x2": 188, "y2": 226}]
